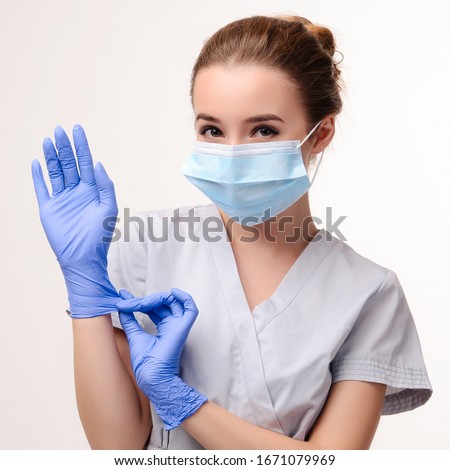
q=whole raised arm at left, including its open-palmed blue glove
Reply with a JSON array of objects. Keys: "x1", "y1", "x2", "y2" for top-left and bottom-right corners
[{"x1": 32, "y1": 125, "x2": 151, "y2": 449}]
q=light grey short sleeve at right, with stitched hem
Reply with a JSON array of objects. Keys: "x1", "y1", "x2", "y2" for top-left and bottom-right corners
[{"x1": 331, "y1": 270, "x2": 433, "y2": 415}]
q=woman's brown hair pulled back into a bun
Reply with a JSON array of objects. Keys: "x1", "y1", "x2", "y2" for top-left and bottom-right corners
[{"x1": 190, "y1": 15, "x2": 342, "y2": 126}]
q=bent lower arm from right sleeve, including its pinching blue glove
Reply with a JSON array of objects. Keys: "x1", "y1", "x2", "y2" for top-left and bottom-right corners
[{"x1": 116, "y1": 289, "x2": 386, "y2": 450}]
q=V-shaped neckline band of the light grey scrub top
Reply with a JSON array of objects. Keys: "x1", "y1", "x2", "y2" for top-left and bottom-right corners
[{"x1": 197, "y1": 204, "x2": 339, "y2": 333}]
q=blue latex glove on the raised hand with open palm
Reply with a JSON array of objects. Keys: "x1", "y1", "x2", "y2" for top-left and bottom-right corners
[{"x1": 32, "y1": 125, "x2": 120, "y2": 318}]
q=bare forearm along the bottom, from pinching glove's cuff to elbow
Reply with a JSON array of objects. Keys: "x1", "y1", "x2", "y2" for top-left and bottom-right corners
[{"x1": 181, "y1": 401, "x2": 319, "y2": 450}]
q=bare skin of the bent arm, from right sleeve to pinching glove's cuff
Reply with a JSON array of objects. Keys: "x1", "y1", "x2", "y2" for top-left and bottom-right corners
[{"x1": 181, "y1": 381, "x2": 386, "y2": 450}]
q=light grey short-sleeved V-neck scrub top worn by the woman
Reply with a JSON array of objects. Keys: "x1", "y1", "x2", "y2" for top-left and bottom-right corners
[{"x1": 108, "y1": 204, "x2": 432, "y2": 449}]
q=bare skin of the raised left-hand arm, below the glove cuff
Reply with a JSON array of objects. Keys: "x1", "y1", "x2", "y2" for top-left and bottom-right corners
[{"x1": 72, "y1": 315, "x2": 152, "y2": 449}]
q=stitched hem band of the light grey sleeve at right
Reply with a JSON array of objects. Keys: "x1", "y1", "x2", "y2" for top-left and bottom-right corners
[{"x1": 331, "y1": 359, "x2": 433, "y2": 415}]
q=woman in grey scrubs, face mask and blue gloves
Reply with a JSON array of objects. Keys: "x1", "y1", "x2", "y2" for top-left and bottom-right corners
[{"x1": 33, "y1": 16, "x2": 432, "y2": 449}]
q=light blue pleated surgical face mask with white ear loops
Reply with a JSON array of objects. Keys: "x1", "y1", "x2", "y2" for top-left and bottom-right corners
[{"x1": 180, "y1": 121, "x2": 323, "y2": 226}]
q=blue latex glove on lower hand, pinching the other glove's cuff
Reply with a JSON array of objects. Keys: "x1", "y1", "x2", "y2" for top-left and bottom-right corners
[{"x1": 117, "y1": 289, "x2": 208, "y2": 431}]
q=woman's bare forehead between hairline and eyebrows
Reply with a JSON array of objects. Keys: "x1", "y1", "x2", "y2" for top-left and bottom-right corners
[{"x1": 193, "y1": 65, "x2": 302, "y2": 117}]
